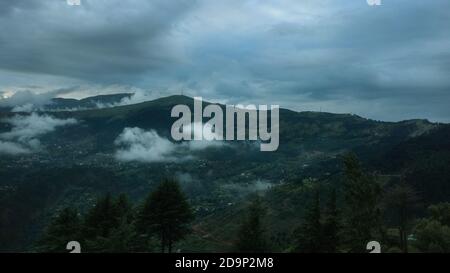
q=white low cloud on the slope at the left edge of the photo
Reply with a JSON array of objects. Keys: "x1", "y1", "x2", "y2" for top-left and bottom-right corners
[{"x1": 0, "y1": 113, "x2": 77, "y2": 155}]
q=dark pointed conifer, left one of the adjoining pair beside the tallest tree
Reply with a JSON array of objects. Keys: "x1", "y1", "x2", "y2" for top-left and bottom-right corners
[{"x1": 294, "y1": 192, "x2": 323, "y2": 253}]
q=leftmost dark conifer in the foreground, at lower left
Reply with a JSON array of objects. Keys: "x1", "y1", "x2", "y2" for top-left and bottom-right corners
[{"x1": 37, "y1": 208, "x2": 81, "y2": 252}]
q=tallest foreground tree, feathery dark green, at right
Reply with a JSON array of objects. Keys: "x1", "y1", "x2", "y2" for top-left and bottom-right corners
[{"x1": 343, "y1": 154, "x2": 381, "y2": 252}]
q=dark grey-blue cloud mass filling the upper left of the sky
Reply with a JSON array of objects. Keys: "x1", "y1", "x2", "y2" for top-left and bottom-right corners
[{"x1": 0, "y1": 0, "x2": 195, "y2": 82}]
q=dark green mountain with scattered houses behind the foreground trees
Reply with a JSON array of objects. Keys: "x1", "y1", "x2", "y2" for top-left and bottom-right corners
[{"x1": 0, "y1": 94, "x2": 450, "y2": 251}]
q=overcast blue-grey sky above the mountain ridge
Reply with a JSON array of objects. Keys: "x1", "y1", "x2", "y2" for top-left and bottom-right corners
[{"x1": 0, "y1": 0, "x2": 450, "y2": 122}]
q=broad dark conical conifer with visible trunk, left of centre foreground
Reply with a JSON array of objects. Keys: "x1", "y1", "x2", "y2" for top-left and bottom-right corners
[{"x1": 137, "y1": 179, "x2": 194, "y2": 253}]
